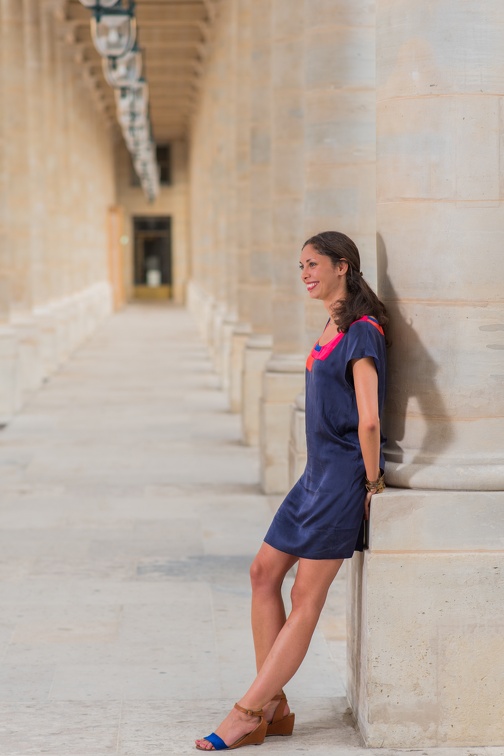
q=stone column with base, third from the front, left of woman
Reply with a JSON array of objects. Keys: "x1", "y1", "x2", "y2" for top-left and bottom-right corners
[{"x1": 260, "y1": 0, "x2": 305, "y2": 493}]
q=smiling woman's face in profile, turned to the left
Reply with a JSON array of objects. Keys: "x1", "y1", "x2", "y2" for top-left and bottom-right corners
[{"x1": 299, "y1": 244, "x2": 348, "y2": 305}]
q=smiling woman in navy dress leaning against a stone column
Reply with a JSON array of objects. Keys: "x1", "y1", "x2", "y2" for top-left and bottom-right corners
[{"x1": 196, "y1": 231, "x2": 387, "y2": 751}]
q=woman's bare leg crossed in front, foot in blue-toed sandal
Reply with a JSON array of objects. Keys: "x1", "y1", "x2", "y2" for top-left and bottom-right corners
[{"x1": 196, "y1": 559, "x2": 343, "y2": 750}]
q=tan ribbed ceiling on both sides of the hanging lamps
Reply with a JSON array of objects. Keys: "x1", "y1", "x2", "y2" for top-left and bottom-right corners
[{"x1": 61, "y1": 0, "x2": 218, "y2": 143}]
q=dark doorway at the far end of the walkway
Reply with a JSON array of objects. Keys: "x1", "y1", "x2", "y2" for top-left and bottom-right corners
[{"x1": 133, "y1": 216, "x2": 172, "y2": 299}]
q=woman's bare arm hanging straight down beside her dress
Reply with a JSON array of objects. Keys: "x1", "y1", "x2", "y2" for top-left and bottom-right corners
[{"x1": 352, "y1": 357, "x2": 380, "y2": 519}]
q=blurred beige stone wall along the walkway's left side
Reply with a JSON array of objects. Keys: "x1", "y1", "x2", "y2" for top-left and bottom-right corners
[{"x1": 0, "y1": 0, "x2": 115, "y2": 422}]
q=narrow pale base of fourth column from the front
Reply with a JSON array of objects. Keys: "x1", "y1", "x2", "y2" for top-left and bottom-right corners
[{"x1": 241, "y1": 334, "x2": 273, "y2": 446}]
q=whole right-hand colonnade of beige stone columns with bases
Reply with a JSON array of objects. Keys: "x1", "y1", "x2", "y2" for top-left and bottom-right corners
[{"x1": 190, "y1": 0, "x2": 504, "y2": 748}]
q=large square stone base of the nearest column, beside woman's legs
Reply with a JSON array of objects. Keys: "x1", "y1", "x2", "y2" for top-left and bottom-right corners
[{"x1": 348, "y1": 489, "x2": 504, "y2": 748}]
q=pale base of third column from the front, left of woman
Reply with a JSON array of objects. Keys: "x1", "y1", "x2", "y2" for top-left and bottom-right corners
[{"x1": 259, "y1": 355, "x2": 305, "y2": 494}]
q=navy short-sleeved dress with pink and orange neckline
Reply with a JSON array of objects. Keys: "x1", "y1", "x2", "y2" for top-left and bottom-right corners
[{"x1": 264, "y1": 315, "x2": 386, "y2": 559}]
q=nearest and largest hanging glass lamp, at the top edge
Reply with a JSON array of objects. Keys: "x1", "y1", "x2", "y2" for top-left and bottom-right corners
[{"x1": 91, "y1": 0, "x2": 136, "y2": 58}]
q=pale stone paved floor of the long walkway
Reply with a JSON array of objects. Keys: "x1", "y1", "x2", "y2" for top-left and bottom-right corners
[{"x1": 0, "y1": 305, "x2": 503, "y2": 756}]
